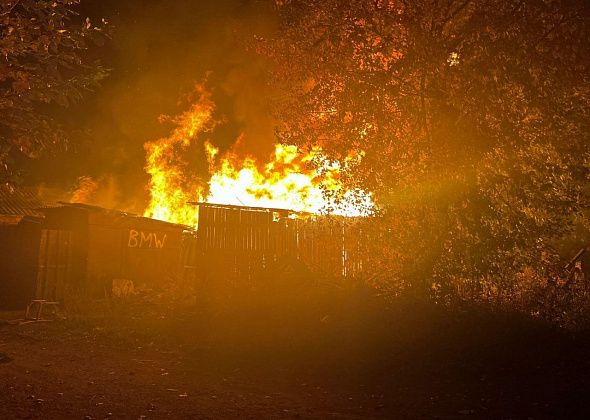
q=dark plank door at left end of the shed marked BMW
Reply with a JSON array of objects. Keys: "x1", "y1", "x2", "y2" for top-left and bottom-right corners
[{"x1": 36, "y1": 229, "x2": 72, "y2": 301}]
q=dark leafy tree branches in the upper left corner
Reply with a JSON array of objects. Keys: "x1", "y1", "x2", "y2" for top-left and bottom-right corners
[{"x1": 0, "y1": 0, "x2": 107, "y2": 182}]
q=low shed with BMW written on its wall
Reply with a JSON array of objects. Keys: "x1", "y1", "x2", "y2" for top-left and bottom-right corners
[{"x1": 36, "y1": 203, "x2": 194, "y2": 301}]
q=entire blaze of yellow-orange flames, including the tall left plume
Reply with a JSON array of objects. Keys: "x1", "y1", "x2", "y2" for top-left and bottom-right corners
[{"x1": 144, "y1": 89, "x2": 374, "y2": 226}]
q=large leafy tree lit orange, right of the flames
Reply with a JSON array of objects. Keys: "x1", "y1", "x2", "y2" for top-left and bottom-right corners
[{"x1": 257, "y1": 0, "x2": 590, "y2": 302}]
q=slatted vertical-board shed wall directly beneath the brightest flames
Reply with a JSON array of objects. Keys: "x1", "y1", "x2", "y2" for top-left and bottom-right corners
[{"x1": 198, "y1": 204, "x2": 362, "y2": 282}]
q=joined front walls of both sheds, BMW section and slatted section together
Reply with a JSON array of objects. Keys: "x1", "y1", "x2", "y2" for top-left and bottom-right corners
[{"x1": 32, "y1": 204, "x2": 366, "y2": 300}]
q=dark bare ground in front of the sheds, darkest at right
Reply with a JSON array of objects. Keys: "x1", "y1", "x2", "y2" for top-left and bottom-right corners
[{"x1": 0, "y1": 290, "x2": 590, "y2": 419}]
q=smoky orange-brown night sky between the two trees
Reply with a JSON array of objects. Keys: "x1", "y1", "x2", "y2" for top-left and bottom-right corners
[{"x1": 31, "y1": 0, "x2": 274, "y2": 211}]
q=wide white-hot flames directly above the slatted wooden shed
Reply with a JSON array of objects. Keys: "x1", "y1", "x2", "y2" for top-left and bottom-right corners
[{"x1": 207, "y1": 144, "x2": 373, "y2": 216}]
